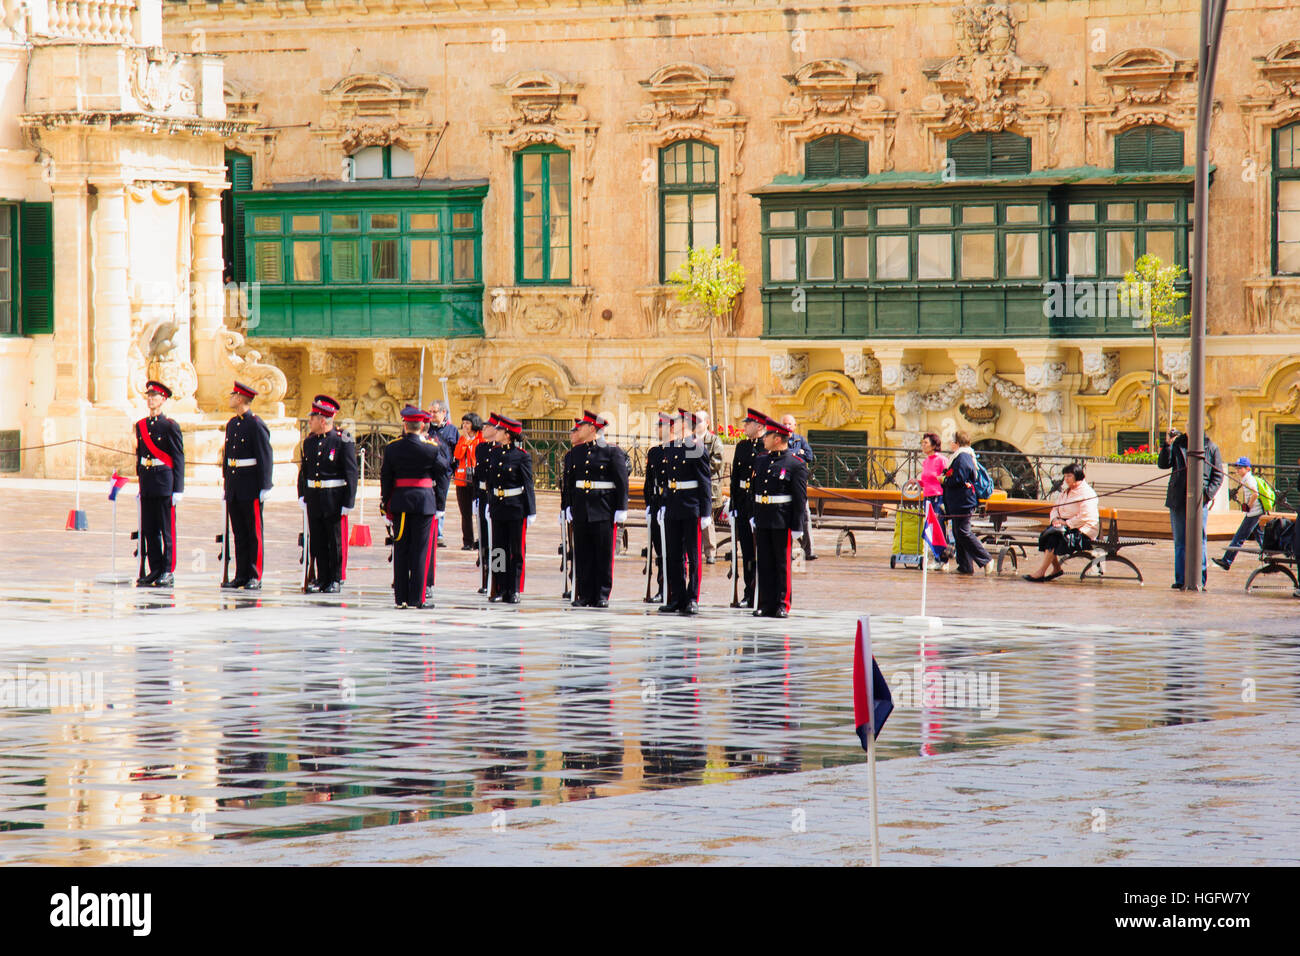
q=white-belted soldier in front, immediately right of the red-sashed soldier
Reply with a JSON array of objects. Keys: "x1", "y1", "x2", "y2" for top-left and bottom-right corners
[{"x1": 488, "y1": 415, "x2": 537, "y2": 604}]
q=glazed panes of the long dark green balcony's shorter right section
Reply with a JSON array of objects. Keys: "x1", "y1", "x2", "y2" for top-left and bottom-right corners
[{"x1": 1053, "y1": 193, "x2": 1191, "y2": 280}]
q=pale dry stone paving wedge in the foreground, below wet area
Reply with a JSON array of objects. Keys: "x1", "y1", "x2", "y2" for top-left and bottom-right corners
[{"x1": 187, "y1": 713, "x2": 1300, "y2": 866}]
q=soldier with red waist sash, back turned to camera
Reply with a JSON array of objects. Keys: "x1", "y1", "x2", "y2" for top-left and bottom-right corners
[{"x1": 380, "y1": 405, "x2": 447, "y2": 607}]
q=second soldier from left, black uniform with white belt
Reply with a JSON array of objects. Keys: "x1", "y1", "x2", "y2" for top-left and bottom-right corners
[{"x1": 221, "y1": 382, "x2": 272, "y2": 591}]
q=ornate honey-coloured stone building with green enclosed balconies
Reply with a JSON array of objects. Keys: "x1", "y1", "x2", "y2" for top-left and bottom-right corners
[{"x1": 0, "y1": 0, "x2": 1300, "y2": 478}]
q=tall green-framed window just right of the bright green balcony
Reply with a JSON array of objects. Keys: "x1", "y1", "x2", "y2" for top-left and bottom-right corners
[{"x1": 515, "y1": 144, "x2": 571, "y2": 285}]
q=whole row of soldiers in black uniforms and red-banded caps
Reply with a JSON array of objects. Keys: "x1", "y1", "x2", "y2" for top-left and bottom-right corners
[{"x1": 137, "y1": 381, "x2": 807, "y2": 617}]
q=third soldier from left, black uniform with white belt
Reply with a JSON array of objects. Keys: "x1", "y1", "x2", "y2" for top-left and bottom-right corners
[{"x1": 298, "y1": 395, "x2": 356, "y2": 594}]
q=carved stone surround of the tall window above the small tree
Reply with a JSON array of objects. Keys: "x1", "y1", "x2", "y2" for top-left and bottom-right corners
[{"x1": 628, "y1": 62, "x2": 749, "y2": 277}]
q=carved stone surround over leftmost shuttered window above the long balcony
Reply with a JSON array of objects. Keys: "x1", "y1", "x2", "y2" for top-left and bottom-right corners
[{"x1": 776, "y1": 59, "x2": 898, "y2": 176}]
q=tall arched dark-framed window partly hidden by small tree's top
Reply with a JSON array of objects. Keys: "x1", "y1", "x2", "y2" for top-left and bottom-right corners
[{"x1": 659, "y1": 139, "x2": 718, "y2": 282}]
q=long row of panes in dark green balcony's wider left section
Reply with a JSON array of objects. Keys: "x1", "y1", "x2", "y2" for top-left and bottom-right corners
[{"x1": 764, "y1": 198, "x2": 1047, "y2": 284}]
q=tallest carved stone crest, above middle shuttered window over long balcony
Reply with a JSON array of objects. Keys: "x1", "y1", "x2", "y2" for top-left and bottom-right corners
[{"x1": 917, "y1": 0, "x2": 1062, "y2": 169}]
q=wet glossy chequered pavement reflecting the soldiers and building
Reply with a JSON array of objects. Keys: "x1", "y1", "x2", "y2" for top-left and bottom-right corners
[{"x1": 0, "y1": 587, "x2": 1300, "y2": 862}]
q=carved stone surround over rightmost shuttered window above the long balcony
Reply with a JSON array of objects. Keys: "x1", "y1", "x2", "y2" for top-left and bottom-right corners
[{"x1": 1080, "y1": 47, "x2": 1196, "y2": 166}]
